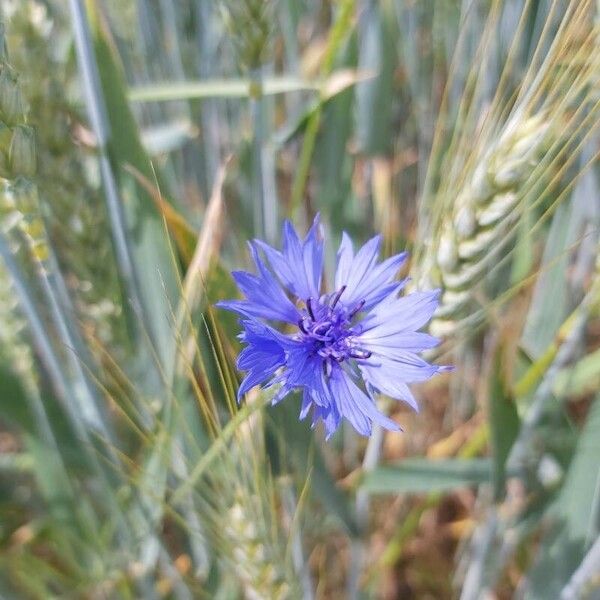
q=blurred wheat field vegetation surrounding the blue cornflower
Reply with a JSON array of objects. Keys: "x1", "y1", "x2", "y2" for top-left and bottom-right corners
[{"x1": 0, "y1": 0, "x2": 600, "y2": 600}]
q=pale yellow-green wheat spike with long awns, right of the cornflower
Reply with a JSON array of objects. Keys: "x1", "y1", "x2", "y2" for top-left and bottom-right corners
[{"x1": 417, "y1": 0, "x2": 600, "y2": 336}]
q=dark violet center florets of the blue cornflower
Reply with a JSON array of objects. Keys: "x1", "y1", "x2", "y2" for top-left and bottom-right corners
[{"x1": 298, "y1": 286, "x2": 371, "y2": 375}]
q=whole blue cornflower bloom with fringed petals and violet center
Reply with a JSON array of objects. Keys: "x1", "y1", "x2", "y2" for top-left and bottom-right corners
[{"x1": 218, "y1": 217, "x2": 447, "y2": 438}]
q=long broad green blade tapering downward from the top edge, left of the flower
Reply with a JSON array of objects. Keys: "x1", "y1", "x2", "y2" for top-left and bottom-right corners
[{"x1": 70, "y1": 0, "x2": 177, "y2": 368}]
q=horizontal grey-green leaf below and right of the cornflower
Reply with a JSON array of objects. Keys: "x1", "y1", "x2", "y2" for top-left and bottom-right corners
[{"x1": 361, "y1": 458, "x2": 492, "y2": 494}]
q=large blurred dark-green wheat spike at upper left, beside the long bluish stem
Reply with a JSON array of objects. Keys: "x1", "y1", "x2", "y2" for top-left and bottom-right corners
[{"x1": 5, "y1": 2, "x2": 123, "y2": 343}]
